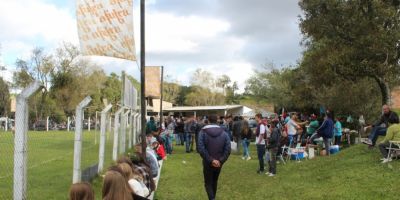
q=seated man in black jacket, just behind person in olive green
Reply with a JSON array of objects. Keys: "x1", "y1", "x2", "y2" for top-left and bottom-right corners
[{"x1": 363, "y1": 105, "x2": 399, "y2": 148}]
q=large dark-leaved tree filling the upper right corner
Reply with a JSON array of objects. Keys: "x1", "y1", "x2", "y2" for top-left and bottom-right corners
[{"x1": 299, "y1": 0, "x2": 400, "y2": 104}]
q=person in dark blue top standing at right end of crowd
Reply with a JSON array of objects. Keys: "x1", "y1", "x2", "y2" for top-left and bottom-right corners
[{"x1": 307, "y1": 112, "x2": 334, "y2": 156}]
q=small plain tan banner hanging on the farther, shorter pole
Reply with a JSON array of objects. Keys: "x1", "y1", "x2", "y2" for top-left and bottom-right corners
[{"x1": 145, "y1": 67, "x2": 161, "y2": 98}]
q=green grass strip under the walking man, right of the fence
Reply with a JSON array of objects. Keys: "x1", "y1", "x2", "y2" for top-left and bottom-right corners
[{"x1": 156, "y1": 145, "x2": 400, "y2": 200}]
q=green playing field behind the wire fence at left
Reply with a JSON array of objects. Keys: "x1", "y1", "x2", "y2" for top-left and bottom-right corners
[{"x1": 0, "y1": 131, "x2": 112, "y2": 200}]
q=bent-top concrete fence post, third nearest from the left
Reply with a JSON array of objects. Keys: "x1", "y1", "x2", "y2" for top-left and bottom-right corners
[{"x1": 97, "y1": 104, "x2": 112, "y2": 173}]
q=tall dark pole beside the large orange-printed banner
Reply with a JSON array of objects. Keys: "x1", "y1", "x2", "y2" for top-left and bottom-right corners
[{"x1": 140, "y1": 0, "x2": 146, "y2": 157}]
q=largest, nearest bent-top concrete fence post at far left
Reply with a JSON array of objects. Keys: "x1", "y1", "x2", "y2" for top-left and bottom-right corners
[{"x1": 13, "y1": 81, "x2": 42, "y2": 200}]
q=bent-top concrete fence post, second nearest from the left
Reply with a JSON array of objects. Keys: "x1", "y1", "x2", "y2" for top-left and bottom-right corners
[{"x1": 72, "y1": 96, "x2": 92, "y2": 183}]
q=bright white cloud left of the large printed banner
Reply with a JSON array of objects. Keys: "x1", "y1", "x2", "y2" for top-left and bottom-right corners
[{"x1": 0, "y1": 0, "x2": 78, "y2": 65}]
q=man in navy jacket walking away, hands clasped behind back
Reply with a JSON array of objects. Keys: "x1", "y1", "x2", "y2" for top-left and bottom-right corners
[{"x1": 198, "y1": 115, "x2": 231, "y2": 200}]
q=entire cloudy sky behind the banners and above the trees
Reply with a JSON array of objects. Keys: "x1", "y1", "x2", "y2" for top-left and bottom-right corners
[{"x1": 0, "y1": 0, "x2": 302, "y2": 89}]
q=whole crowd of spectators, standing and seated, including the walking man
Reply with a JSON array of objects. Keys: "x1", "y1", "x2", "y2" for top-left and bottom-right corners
[{"x1": 70, "y1": 105, "x2": 400, "y2": 200}]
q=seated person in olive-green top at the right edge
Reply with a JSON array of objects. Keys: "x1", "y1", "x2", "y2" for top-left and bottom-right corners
[{"x1": 378, "y1": 124, "x2": 400, "y2": 163}]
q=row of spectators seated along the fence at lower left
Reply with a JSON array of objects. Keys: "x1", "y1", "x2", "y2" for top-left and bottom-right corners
[{"x1": 69, "y1": 138, "x2": 163, "y2": 200}]
